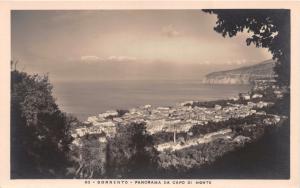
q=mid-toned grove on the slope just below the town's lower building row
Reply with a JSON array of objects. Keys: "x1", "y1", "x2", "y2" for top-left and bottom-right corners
[{"x1": 158, "y1": 115, "x2": 282, "y2": 172}]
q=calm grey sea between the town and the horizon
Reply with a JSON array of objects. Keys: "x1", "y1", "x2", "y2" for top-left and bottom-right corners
[{"x1": 53, "y1": 80, "x2": 251, "y2": 121}]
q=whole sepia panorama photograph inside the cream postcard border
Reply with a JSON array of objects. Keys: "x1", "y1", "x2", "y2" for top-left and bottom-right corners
[{"x1": 10, "y1": 9, "x2": 291, "y2": 180}]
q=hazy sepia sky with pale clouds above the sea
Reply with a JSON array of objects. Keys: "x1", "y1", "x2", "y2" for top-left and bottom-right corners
[{"x1": 11, "y1": 10, "x2": 271, "y2": 81}]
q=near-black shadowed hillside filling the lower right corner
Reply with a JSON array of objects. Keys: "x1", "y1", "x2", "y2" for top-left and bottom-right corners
[{"x1": 157, "y1": 121, "x2": 290, "y2": 179}]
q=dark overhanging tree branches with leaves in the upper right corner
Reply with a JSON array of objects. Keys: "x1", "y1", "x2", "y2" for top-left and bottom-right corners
[{"x1": 203, "y1": 9, "x2": 290, "y2": 88}]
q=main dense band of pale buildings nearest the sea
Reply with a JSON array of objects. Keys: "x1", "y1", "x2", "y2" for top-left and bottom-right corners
[{"x1": 72, "y1": 94, "x2": 271, "y2": 138}]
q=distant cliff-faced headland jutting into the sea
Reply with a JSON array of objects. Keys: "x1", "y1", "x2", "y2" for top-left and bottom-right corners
[{"x1": 203, "y1": 60, "x2": 275, "y2": 84}]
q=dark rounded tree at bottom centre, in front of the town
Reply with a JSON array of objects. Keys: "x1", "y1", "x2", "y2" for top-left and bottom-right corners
[{"x1": 106, "y1": 123, "x2": 158, "y2": 178}]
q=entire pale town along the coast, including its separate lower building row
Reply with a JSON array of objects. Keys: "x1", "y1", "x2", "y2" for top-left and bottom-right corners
[{"x1": 72, "y1": 82, "x2": 282, "y2": 151}]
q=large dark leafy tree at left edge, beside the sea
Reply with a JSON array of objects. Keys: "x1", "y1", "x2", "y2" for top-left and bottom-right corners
[{"x1": 11, "y1": 69, "x2": 72, "y2": 178}]
